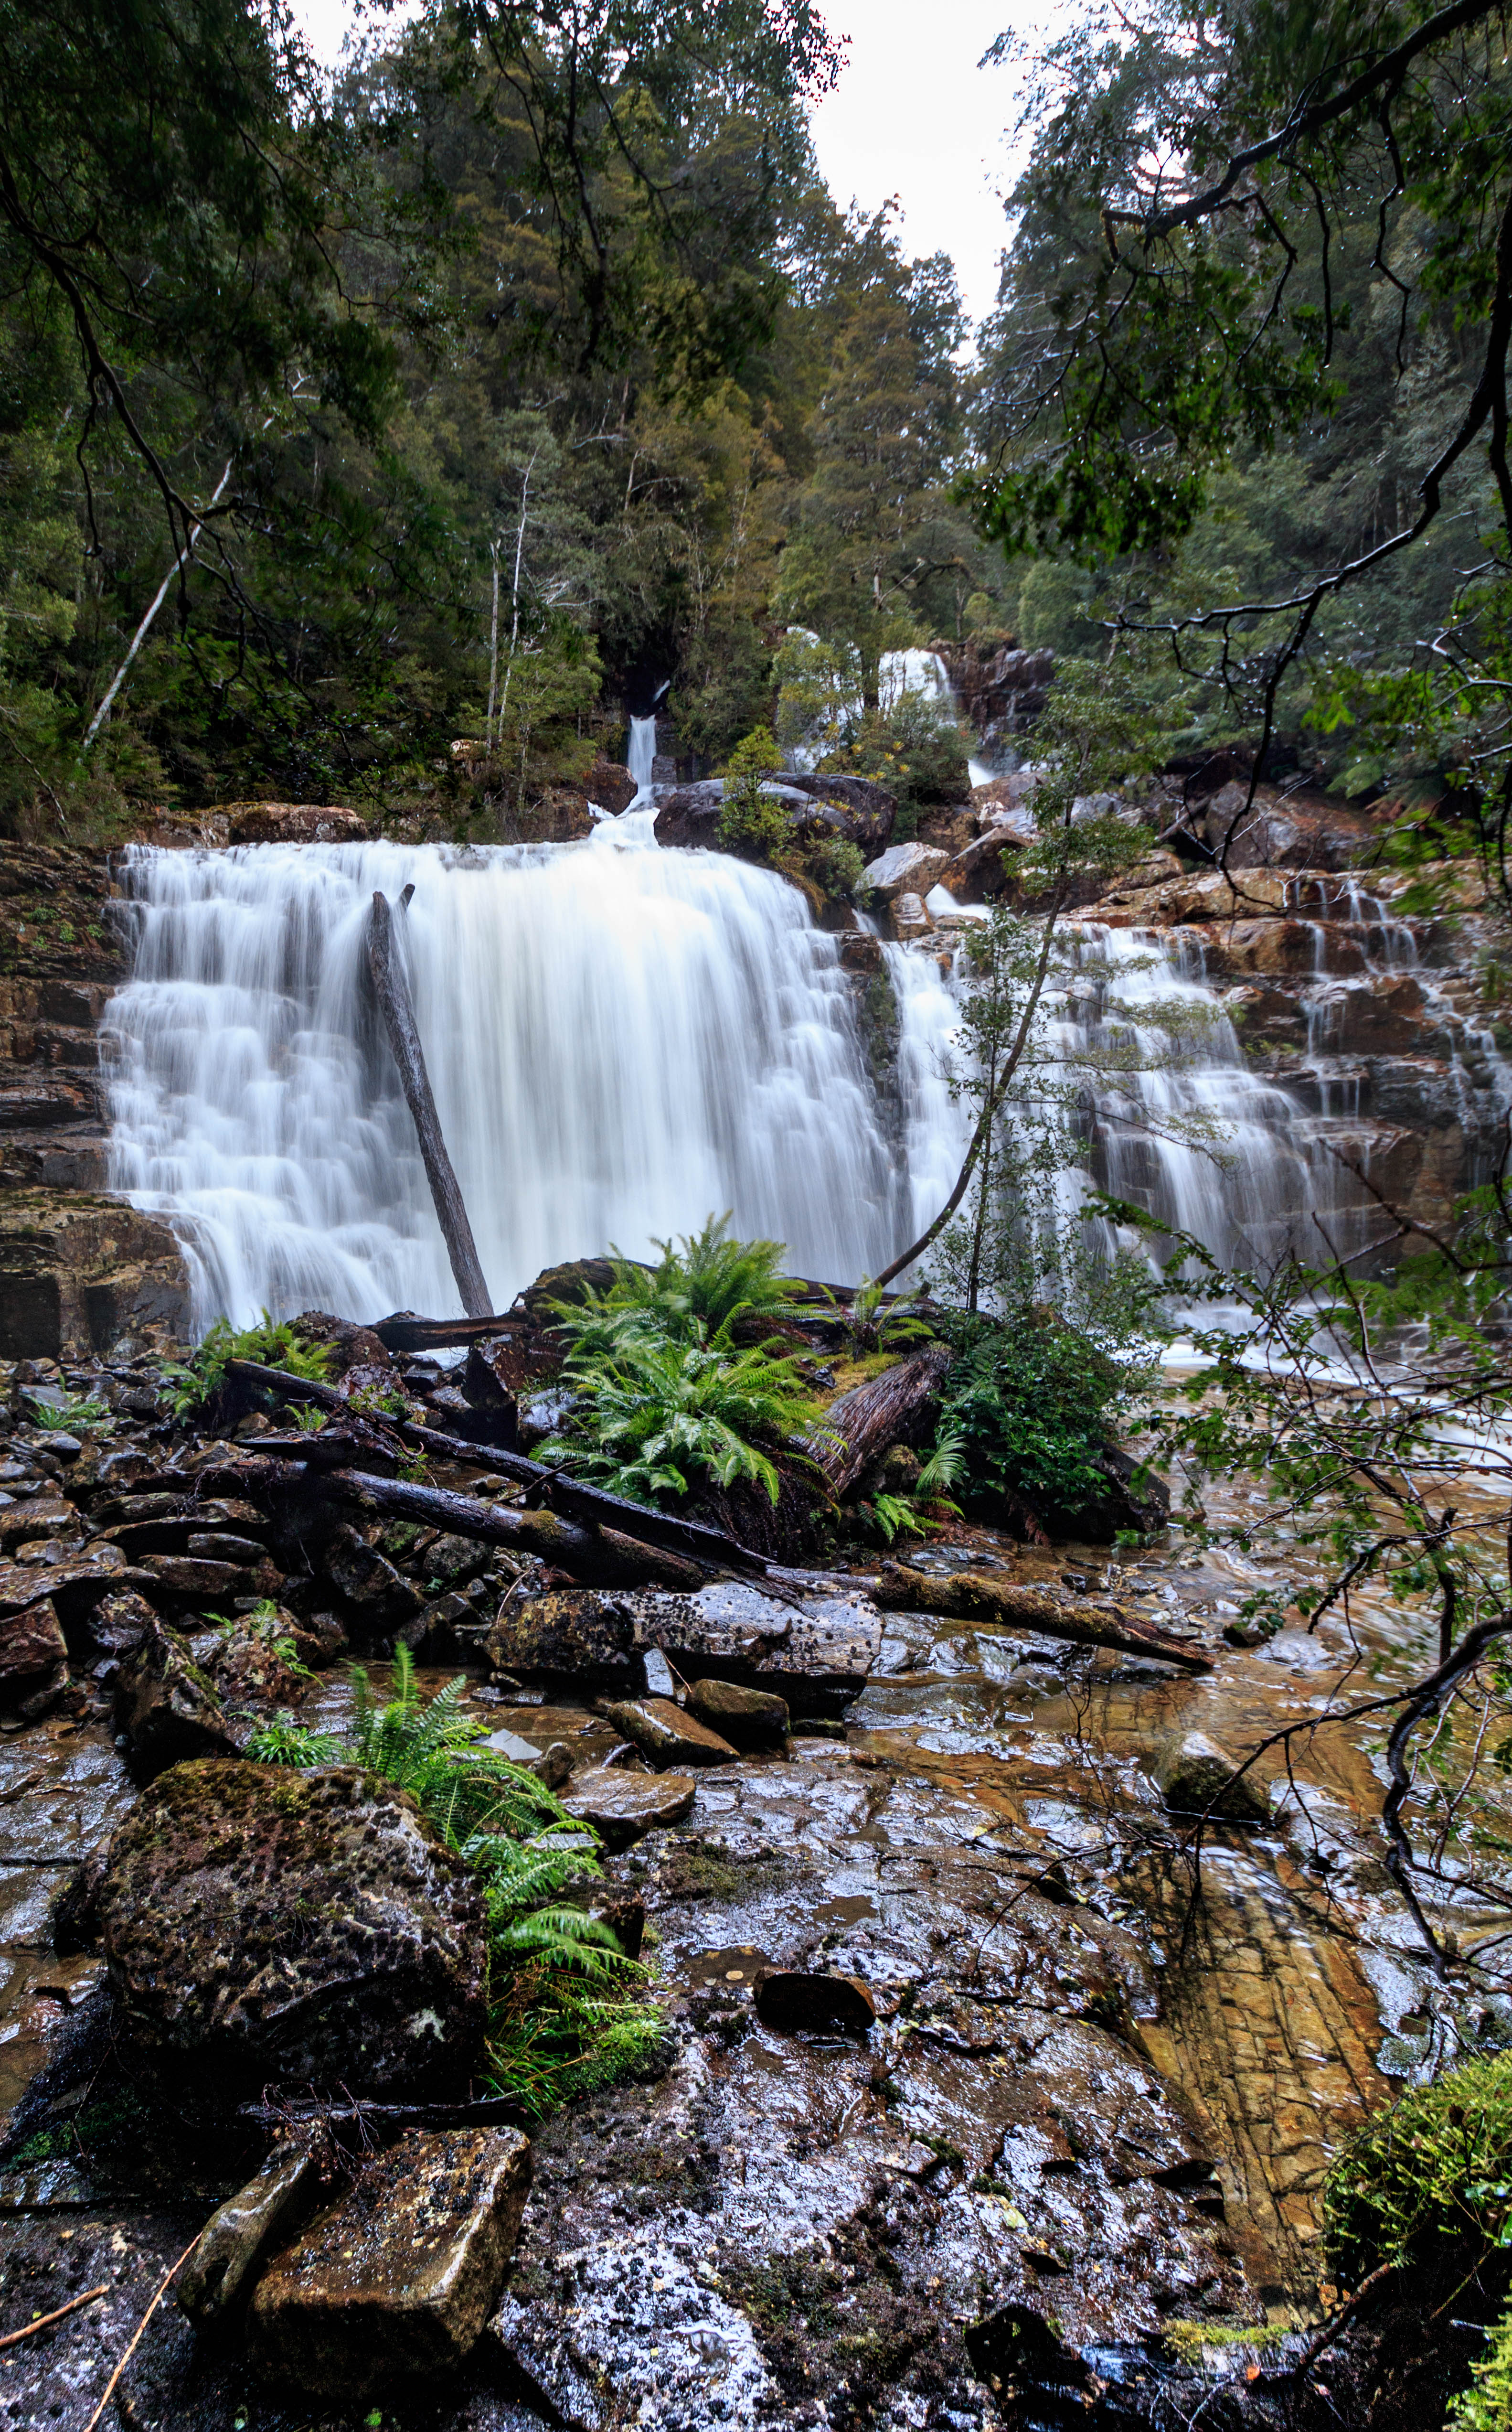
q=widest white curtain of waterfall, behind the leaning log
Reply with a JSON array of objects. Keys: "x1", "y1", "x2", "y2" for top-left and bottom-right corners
[{"x1": 105, "y1": 832, "x2": 907, "y2": 1326}]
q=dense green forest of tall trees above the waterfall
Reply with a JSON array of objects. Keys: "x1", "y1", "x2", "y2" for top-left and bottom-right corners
[{"x1": 0, "y1": 0, "x2": 1507, "y2": 870}]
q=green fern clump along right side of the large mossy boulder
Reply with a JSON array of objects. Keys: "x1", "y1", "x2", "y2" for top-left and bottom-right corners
[{"x1": 248, "y1": 1647, "x2": 661, "y2": 2113}]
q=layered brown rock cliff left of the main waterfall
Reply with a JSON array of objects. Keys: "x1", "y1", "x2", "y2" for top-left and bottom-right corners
[{"x1": 0, "y1": 844, "x2": 187, "y2": 1360}]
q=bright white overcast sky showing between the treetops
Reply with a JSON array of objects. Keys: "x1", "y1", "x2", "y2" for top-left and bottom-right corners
[{"x1": 294, "y1": 0, "x2": 1040, "y2": 319}]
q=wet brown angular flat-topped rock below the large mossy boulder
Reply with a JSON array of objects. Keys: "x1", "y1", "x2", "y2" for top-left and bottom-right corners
[{"x1": 248, "y1": 2128, "x2": 530, "y2": 2405}]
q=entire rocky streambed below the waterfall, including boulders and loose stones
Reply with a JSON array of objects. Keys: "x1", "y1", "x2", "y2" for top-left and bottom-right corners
[{"x1": 0, "y1": 1320, "x2": 1495, "y2": 2432}]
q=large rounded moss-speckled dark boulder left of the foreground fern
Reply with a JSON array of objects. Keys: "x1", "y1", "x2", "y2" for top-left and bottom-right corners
[{"x1": 97, "y1": 1761, "x2": 489, "y2": 2094}]
